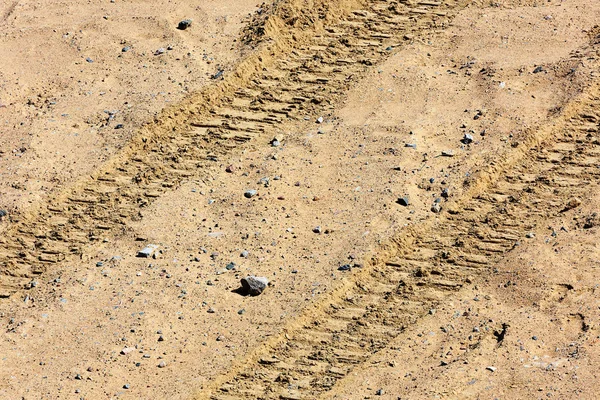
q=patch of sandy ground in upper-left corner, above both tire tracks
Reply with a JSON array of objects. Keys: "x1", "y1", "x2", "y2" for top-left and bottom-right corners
[{"x1": 0, "y1": 0, "x2": 256, "y2": 211}]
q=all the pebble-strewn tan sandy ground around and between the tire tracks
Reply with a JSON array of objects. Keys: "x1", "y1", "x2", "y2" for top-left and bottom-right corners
[{"x1": 0, "y1": 0, "x2": 600, "y2": 399}]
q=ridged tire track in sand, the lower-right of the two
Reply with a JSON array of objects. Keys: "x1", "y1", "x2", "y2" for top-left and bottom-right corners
[{"x1": 196, "y1": 57, "x2": 600, "y2": 400}]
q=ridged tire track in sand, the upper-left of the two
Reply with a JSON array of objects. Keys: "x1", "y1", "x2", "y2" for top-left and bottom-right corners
[{"x1": 0, "y1": 0, "x2": 469, "y2": 297}]
